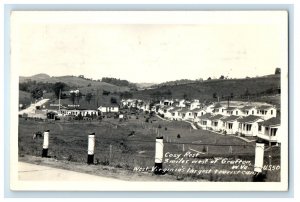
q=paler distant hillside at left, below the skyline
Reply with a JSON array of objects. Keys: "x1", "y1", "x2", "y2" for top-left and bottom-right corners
[{"x1": 19, "y1": 74, "x2": 129, "y2": 93}]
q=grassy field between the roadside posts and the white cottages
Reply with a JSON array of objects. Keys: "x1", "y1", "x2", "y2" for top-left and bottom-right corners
[{"x1": 19, "y1": 114, "x2": 280, "y2": 181}]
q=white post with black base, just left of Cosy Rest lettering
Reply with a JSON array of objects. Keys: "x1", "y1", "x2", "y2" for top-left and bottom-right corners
[{"x1": 154, "y1": 137, "x2": 164, "y2": 175}]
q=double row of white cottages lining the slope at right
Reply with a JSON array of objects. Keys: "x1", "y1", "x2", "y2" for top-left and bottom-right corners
[{"x1": 157, "y1": 104, "x2": 281, "y2": 143}]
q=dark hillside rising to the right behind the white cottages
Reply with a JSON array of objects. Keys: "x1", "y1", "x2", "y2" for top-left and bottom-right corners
[{"x1": 133, "y1": 75, "x2": 280, "y2": 101}]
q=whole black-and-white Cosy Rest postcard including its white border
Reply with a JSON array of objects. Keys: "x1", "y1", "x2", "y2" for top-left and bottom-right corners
[{"x1": 10, "y1": 10, "x2": 289, "y2": 191}]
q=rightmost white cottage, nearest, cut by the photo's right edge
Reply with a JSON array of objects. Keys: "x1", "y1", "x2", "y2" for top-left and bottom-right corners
[{"x1": 257, "y1": 117, "x2": 282, "y2": 143}]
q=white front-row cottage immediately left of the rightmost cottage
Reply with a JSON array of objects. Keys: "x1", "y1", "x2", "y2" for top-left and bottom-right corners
[{"x1": 238, "y1": 115, "x2": 263, "y2": 136}]
